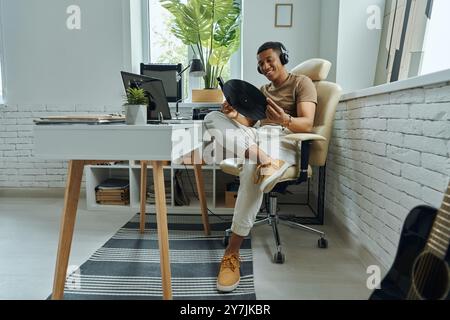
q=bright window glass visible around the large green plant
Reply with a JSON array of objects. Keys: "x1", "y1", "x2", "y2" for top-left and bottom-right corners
[{"x1": 148, "y1": 0, "x2": 240, "y2": 99}]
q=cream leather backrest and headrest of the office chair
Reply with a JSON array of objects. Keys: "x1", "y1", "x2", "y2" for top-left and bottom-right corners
[{"x1": 291, "y1": 59, "x2": 342, "y2": 167}]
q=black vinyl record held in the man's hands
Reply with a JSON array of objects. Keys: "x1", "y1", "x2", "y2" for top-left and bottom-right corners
[{"x1": 222, "y1": 79, "x2": 267, "y2": 120}]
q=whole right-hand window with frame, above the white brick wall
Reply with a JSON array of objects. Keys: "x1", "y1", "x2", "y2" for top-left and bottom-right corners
[{"x1": 375, "y1": 0, "x2": 450, "y2": 84}]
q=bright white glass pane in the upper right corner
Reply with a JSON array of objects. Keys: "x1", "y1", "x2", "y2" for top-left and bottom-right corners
[{"x1": 420, "y1": 0, "x2": 450, "y2": 74}]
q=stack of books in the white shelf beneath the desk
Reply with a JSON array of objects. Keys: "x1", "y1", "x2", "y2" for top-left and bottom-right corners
[{"x1": 95, "y1": 179, "x2": 130, "y2": 205}]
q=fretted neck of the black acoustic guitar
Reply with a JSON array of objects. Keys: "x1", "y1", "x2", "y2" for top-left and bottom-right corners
[{"x1": 426, "y1": 183, "x2": 450, "y2": 259}]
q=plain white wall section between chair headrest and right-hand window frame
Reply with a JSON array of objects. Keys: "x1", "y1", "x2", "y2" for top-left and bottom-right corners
[{"x1": 336, "y1": 0, "x2": 385, "y2": 92}]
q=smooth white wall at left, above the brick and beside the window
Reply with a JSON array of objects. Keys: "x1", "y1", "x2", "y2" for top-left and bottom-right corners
[{"x1": 1, "y1": 0, "x2": 131, "y2": 105}]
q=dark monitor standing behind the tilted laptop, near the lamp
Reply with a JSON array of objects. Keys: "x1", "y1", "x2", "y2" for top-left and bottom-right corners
[{"x1": 141, "y1": 63, "x2": 183, "y2": 102}]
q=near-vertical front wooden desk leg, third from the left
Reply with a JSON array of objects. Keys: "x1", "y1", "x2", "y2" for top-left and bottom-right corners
[{"x1": 152, "y1": 161, "x2": 172, "y2": 300}]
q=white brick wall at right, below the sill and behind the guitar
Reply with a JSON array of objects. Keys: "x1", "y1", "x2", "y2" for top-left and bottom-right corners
[{"x1": 325, "y1": 83, "x2": 450, "y2": 268}]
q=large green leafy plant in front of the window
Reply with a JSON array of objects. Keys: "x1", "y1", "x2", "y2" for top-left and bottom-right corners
[{"x1": 160, "y1": 0, "x2": 241, "y2": 88}]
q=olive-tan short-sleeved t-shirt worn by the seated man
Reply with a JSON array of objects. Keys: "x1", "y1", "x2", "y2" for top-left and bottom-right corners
[{"x1": 260, "y1": 73, "x2": 317, "y2": 125}]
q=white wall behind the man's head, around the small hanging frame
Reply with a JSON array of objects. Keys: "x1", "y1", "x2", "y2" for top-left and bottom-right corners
[{"x1": 242, "y1": 0, "x2": 320, "y2": 87}]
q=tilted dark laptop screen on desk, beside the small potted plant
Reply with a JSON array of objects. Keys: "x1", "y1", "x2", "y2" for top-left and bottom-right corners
[{"x1": 120, "y1": 71, "x2": 172, "y2": 121}]
